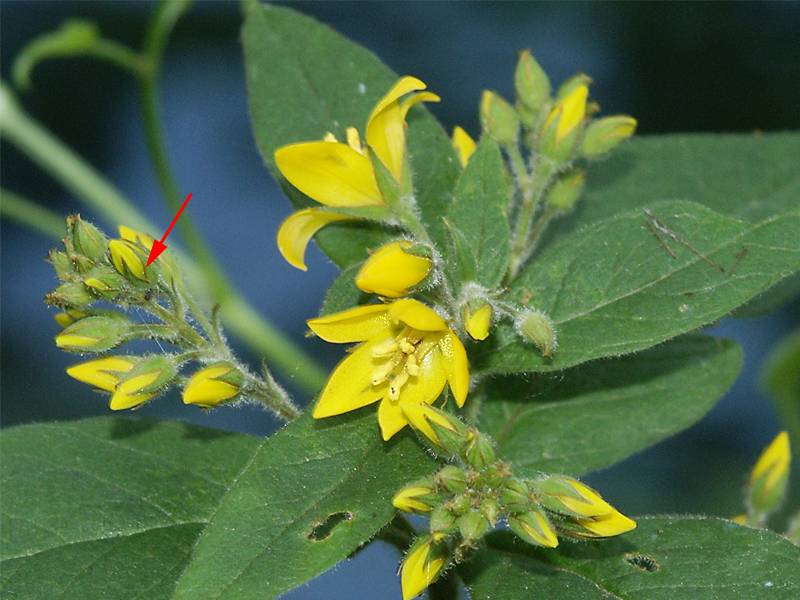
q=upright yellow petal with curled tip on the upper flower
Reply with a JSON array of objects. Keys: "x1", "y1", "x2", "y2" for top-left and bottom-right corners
[{"x1": 367, "y1": 76, "x2": 438, "y2": 181}]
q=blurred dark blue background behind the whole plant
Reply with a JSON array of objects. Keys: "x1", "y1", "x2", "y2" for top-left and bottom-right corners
[{"x1": 0, "y1": 0, "x2": 800, "y2": 598}]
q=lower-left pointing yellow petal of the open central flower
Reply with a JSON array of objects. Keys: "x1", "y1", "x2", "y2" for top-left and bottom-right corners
[{"x1": 313, "y1": 335, "x2": 391, "y2": 419}]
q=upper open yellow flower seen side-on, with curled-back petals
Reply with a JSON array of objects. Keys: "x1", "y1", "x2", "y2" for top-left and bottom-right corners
[{"x1": 275, "y1": 76, "x2": 439, "y2": 271}]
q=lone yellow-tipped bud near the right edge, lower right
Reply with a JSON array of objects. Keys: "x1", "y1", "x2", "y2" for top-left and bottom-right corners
[{"x1": 747, "y1": 431, "x2": 792, "y2": 515}]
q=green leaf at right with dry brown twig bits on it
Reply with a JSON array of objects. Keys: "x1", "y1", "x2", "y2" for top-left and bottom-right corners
[{"x1": 473, "y1": 202, "x2": 800, "y2": 373}]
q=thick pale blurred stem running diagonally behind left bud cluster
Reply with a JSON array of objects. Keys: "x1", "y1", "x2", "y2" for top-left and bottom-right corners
[{"x1": 0, "y1": 82, "x2": 326, "y2": 393}]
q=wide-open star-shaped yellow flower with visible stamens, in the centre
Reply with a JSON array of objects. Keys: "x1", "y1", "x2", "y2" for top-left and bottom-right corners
[{"x1": 308, "y1": 299, "x2": 469, "y2": 440}]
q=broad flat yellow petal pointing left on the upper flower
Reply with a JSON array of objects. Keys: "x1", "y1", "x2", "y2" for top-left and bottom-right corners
[{"x1": 275, "y1": 141, "x2": 383, "y2": 207}]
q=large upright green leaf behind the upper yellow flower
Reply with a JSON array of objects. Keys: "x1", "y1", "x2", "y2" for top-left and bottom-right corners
[{"x1": 243, "y1": 3, "x2": 458, "y2": 267}]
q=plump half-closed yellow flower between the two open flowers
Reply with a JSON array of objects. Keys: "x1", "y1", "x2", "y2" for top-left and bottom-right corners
[{"x1": 356, "y1": 241, "x2": 433, "y2": 298}]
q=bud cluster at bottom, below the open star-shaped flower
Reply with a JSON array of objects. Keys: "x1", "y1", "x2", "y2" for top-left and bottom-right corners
[{"x1": 392, "y1": 406, "x2": 636, "y2": 598}]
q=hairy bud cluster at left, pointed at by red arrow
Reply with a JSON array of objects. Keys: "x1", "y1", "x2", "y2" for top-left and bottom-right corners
[{"x1": 45, "y1": 215, "x2": 288, "y2": 418}]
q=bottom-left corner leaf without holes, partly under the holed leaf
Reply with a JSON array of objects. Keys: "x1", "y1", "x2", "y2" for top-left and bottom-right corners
[{"x1": 0, "y1": 418, "x2": 259, "y2": 600}]
